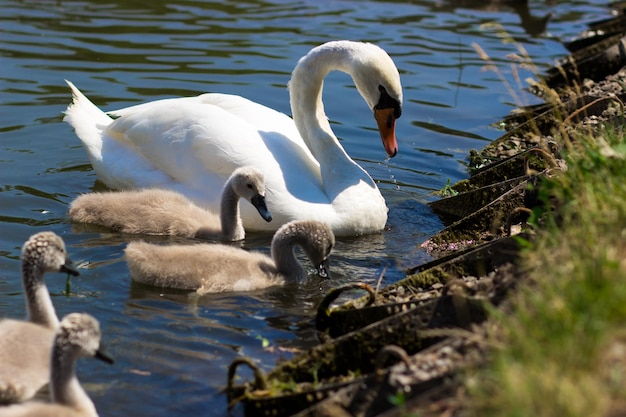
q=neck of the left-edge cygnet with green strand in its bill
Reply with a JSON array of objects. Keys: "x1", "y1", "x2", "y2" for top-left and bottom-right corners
[{"x1": 22, "y1": 262, "x2": 59, "y2": 329}]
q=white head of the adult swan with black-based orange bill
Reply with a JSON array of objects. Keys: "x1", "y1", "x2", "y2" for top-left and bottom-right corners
[{"x1": 350, "y1": 43, "x2": 402, "y2": 157}]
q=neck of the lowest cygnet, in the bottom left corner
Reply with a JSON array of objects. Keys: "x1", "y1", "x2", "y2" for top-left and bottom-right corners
[{"x1": 50, "y1": 343, "x2": 97, "y2": 415}]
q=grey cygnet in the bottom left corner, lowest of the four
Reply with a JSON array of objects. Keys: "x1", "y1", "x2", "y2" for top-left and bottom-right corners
[{"x1": 0, "y1": 313, "x2": 113, "y2": 417}]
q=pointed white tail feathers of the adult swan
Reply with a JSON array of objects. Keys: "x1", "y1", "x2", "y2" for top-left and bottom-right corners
[{"x1": 63, "y1": 80, "x2": 113, "y2": 161}]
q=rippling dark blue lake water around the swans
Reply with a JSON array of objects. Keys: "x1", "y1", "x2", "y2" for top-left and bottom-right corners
[{"x1": 0, "y1": 0, "x2": 609, "y2": 417}]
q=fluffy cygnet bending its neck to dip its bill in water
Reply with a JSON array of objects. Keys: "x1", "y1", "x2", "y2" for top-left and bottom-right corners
[{"x1": 125, "y1": 220, "x2": 335, "y2": 294}]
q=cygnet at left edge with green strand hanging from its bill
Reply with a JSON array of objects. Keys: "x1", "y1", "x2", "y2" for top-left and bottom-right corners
[{"x1": 0, "y1": 232, "x2": 78, "y2": 404}]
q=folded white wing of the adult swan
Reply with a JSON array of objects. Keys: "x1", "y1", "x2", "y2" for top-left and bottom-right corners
[{"x1": 105, "y1": 94, "x2": 323, "y2": 208}]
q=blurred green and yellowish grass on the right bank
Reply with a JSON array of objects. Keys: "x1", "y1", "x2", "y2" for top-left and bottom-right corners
[{"x1": 467, "y1": 122, "x2": 626, "y2": 417}]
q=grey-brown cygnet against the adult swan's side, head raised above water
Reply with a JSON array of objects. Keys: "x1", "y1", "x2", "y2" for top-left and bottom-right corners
[{"x1": 68, "y1": 167, "x2": 272, "y2": 241}]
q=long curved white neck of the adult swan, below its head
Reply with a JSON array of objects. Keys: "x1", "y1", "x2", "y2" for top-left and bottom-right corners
[{"x1": 289, "y1": 46, "x2": 358, "y2": 169}]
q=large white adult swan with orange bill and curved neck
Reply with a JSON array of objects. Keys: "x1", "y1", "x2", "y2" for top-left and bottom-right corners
[{"x1": 64, "y1": 41, "x2": 402, "y2": 236}]
